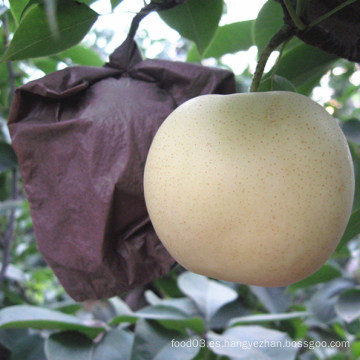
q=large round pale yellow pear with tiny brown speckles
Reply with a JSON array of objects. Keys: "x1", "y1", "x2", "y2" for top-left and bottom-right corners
[{"x1": 144, "y1": 91, "x2": 354, "y2": 287}]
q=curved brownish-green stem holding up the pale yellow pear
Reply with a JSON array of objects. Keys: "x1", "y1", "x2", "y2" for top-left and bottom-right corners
[{"x1": 250, "y1": 25, "x2": 295, "y2": 92}]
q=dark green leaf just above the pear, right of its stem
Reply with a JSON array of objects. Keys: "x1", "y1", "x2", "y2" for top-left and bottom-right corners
[{"x1": 276, "y1": 43, "x2": 337, "y2": 94}]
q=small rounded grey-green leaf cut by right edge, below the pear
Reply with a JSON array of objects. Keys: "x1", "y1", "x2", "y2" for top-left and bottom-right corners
[{"x1": 335, "y1": 289, "x2": 360, "y2": 323}]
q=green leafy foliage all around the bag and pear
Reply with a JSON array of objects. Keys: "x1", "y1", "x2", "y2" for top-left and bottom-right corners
[{"x1": 0, "y1": 0, "x2": 360, "y2": 360}]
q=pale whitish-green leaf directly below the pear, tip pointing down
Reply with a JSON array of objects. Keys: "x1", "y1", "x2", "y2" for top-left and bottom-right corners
[{"x1": 178, "y1": 272, "x2": 238, "y2": 321}]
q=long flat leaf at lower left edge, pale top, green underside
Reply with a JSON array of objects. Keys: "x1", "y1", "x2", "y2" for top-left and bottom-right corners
[{"x1": 0, "y1": 305, "x2": 105, "y2": 338}]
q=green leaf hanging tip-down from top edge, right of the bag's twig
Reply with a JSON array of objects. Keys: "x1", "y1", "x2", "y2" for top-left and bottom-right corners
[{"x1": 159, "y1": 0, "x2": 223, "y2": 54}]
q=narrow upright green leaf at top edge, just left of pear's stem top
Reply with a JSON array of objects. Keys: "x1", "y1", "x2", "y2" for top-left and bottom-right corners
[{"x1": 253, "y1": 0, "x2": 284, "y2": 56}]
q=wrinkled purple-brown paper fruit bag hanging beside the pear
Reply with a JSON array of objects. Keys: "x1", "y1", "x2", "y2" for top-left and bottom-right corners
[{"x1": 9, "y1": 38, "x2": 235, "y2": 301}]
